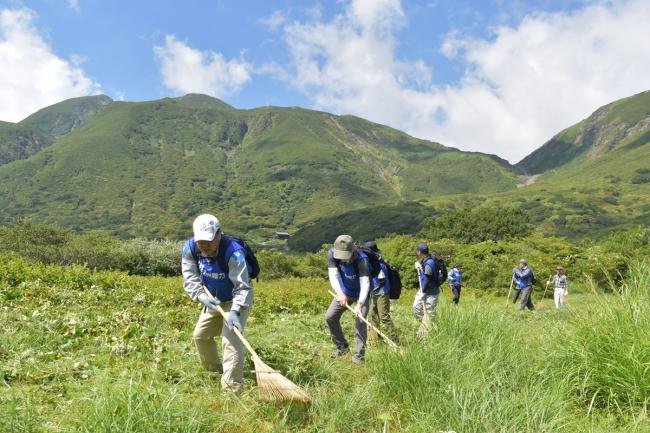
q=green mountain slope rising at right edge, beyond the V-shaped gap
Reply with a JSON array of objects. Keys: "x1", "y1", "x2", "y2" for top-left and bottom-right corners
[{"x1": 436, "y1": 92, "x2": 650, "y2": 238}]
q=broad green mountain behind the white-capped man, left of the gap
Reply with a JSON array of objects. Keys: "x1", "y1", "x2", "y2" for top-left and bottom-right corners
[{"x1": 0, "y1": 95, "x2": 521, "y2": 239}]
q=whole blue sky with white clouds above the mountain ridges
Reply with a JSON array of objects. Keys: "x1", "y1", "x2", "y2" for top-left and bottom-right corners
[{"x1": 0, "y1": 0, "x2": 650, "y2": 162}]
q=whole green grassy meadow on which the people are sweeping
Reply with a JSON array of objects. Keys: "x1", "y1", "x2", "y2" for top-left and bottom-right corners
[{"x1": 0, "y1": 255, "x2": 650, "y2": 433}]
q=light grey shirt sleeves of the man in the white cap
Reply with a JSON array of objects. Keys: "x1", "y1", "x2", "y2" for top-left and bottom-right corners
[{"x1": 181, "y1": 248, "x2": 253, "y2": 311}]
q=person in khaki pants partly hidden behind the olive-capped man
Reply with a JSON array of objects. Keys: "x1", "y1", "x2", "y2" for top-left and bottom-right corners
[{"x1": 363, "y1": 241, "x2": 397, "y2": 341}]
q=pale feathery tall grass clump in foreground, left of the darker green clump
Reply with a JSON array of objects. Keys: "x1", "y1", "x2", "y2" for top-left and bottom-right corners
[{"x1": 370, "y1": 303, "x2": 568, "y2": 432}]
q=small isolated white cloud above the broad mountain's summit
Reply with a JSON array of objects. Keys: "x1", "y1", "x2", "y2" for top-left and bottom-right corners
[{"x1": 154, "y1": 35, "x2": 251, "y2": 97}]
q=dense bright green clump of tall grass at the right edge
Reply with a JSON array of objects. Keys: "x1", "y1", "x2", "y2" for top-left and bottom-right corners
[{"x1": 557, "y1": 262, "x2": 650, "y2": 414}]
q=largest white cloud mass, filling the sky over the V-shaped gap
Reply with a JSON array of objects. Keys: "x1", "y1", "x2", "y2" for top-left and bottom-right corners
[{"x1": 276, "y1": 0, "x2": 650, "y2": 162}]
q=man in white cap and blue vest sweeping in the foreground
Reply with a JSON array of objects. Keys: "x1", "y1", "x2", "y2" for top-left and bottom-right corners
[{"x1": 181, "y1": 214, "x2": 253, "y2": 392}]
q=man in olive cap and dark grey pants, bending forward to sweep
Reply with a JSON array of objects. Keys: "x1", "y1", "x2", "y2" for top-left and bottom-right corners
[{"x1": 325, "y1": 235, "x2": 370, "y2": 364}]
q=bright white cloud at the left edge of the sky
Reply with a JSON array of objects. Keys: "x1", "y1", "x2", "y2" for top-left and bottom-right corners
[{"x1": 0, "y1": 9, "x2": 101, "y2": 122}]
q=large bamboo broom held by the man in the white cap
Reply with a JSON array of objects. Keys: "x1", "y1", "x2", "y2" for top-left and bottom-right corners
[{"x1": 203, "y1": 286, "x2": 311, "y2": 403}]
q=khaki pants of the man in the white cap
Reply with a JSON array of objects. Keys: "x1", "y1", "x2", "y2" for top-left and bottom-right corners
[{"x1": 192, "y1": 302, "x2": 250, "y2": 392}]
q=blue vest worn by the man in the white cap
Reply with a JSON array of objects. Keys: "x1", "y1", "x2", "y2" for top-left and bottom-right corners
[{"x1": 183, "y1": 237, "x2": 250, "y2": 302}]
